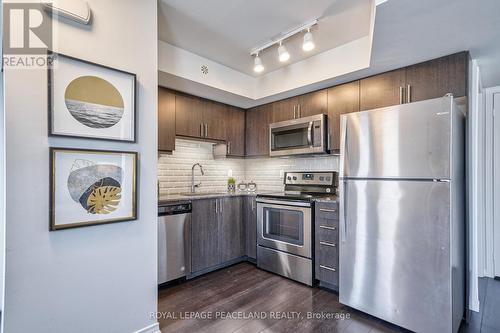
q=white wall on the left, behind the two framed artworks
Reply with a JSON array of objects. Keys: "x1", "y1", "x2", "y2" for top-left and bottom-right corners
[{"x1": 5, "y1": 0, "x2": 157, "y2": 333}]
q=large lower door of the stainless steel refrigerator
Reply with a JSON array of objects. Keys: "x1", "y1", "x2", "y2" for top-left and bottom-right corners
[{"x1": 339, "y1": 180, "x2": 452, "y2": 333}]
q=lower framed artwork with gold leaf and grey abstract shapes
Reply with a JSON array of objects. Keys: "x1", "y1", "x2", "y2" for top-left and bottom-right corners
[{"x1": 50, "y1": 148, "x2": 137, "y2": 231}]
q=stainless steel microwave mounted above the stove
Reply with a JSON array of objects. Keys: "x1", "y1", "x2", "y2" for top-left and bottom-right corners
[{"x1": 269, "y1": 114, "x2": 328, "y2": 156}]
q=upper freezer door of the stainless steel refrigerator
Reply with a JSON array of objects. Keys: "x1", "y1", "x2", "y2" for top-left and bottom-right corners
[{"x1": 340, "y1": 97, "x2": 454, "y2": 179}]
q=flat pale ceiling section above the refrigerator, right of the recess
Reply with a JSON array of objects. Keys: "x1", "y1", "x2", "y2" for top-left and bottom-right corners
[{"x1": 371, "y1": 0, "x2": 500, "y2": 87}]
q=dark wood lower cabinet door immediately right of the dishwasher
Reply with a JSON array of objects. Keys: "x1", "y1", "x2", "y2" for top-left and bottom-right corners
[{"x1": 191, "y1": 199, "x2": 220, "y2": 272}]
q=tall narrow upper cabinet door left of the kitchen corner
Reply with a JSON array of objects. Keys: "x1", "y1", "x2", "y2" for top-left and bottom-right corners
[{"x1": 226, "y1": 106, "x2": 245, "y2": 157}]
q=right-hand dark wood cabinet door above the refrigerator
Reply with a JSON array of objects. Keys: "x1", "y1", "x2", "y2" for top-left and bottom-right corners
[{"x1": 405, "y1": 52, "x2": 469, "y2": 103}]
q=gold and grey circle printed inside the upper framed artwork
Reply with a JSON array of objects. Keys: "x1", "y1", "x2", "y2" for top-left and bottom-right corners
[{"x1": 64, "y1": 76, "x2": 123, "y2": 128}]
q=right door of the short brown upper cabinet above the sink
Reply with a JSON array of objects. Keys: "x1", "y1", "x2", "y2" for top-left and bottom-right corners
[{"x1": 202, "y1": 100, "x2": 228, "y2": 140}]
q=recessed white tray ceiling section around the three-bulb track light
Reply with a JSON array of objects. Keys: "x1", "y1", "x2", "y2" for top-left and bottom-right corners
[{"x1": 158, "y1": 0, "x2": 371, "y2": 76}]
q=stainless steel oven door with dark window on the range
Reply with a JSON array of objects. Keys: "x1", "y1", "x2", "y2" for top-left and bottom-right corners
[{"x1": 257, "y1": 199, "x2": 312, "y2": 258}]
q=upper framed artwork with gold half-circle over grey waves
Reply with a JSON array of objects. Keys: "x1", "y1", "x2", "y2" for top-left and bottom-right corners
[{"x1": 48, "y1": 52, "x2": 136, "y2": 142}]
